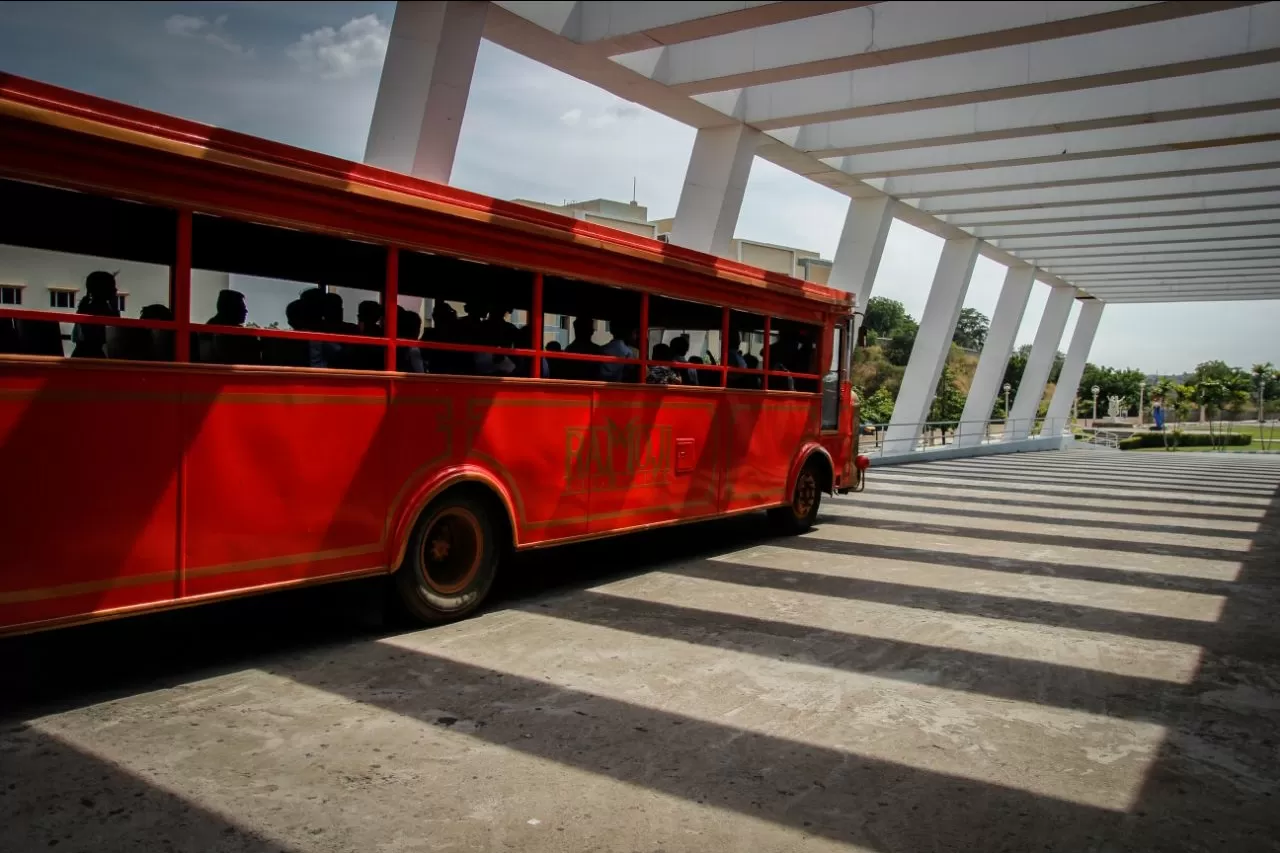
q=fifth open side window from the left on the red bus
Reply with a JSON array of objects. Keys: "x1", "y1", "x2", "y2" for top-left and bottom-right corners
[{"x1": 648, "y1": 296, "x2": 724, "y2": 388}]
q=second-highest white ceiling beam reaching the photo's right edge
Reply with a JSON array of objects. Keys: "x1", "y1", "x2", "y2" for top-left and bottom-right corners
[{"x1": 788, "y1": 64, "x2": 1280, "y2": 158}]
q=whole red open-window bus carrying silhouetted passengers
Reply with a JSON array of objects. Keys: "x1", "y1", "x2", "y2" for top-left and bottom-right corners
[{"x1": 0, "y1": 76, "x2": 867, "y2": 633}]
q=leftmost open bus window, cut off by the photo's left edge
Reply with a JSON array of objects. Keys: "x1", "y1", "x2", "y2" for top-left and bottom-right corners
[{"x1": 0, "y1": 179, "x2": 178, "y2": 361}]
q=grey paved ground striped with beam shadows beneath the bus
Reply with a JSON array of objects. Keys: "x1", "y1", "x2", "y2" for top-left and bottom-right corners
[{"x1": 0, "y1": 451, "x2": 1280, "y2": 853}]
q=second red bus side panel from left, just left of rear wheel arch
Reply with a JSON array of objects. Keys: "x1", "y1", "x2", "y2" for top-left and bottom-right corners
[{"x1": 186, "y1": 370, "x2": 388, "y2": 596}]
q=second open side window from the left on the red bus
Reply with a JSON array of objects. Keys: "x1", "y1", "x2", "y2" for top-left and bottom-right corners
[{"x1": 189, "y1": 214, "x2": 387, "y2": 370}]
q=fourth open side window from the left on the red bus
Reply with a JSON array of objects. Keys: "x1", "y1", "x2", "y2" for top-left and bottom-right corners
[{"x1": 543, "y1": 275, "x2": 641, "y2": 382}]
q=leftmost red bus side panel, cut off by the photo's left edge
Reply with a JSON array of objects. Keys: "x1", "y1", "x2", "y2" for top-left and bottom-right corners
[{"x1": 0, "y1": 361, "x2": 182, "y2": 625}]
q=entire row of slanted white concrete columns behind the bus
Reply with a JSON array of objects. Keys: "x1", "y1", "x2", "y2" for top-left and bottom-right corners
[{"x1": 365, "y1": 13, "x2": 1102, "y2": 453}]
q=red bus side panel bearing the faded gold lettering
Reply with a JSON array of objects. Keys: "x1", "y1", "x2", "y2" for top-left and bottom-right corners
[{"x1": 586, "y1": 386, "x2": 723, "y2": 533}]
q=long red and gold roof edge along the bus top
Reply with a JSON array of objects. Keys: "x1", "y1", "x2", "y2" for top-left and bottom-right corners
[{"x1": 0, "y1": 73, "x2": 852, "y2": 311}]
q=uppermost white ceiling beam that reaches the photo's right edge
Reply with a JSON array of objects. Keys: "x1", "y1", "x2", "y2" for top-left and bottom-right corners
[{"x1": 695, "y1": 5, "x2": 1280, "y2": 131}]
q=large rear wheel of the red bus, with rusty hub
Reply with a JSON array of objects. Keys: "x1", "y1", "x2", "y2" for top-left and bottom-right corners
[{"x1": 396, "y1": 494, "x2": 499, "y2": 622}]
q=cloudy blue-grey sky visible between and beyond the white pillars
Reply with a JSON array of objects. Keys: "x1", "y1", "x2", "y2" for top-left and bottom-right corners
[{"x1": 0, "y1": 1, "x2": 1280, "y2": 374}]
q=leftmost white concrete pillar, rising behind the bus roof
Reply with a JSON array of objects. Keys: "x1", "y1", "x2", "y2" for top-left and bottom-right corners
[{"x1": 365, "y1": 0, "x2": 489, "y2": 183}]
